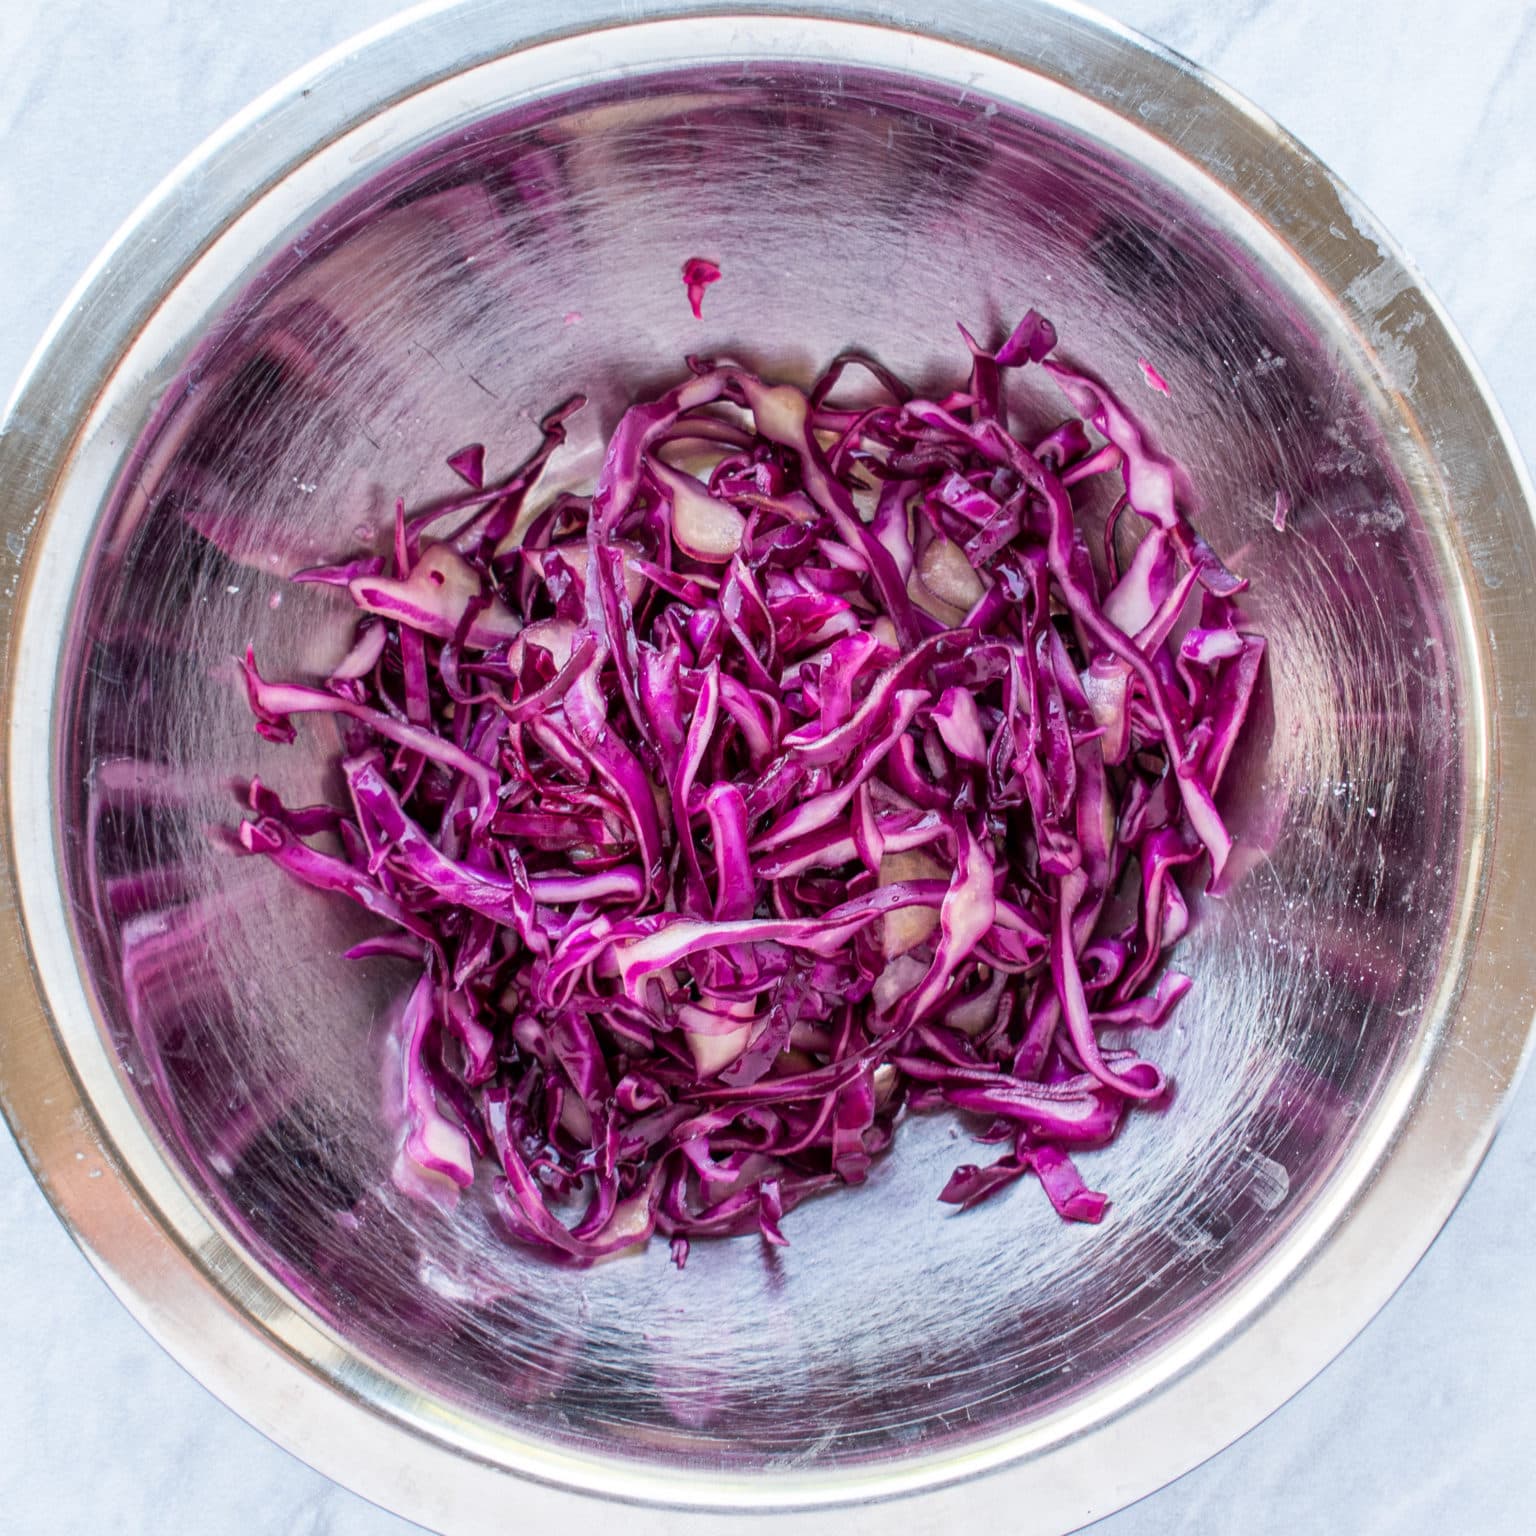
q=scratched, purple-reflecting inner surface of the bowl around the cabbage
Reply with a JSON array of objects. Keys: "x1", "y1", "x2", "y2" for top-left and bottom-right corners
[{"x1": 57, "y1": 63, "x2": 1468, "y2": 1470}]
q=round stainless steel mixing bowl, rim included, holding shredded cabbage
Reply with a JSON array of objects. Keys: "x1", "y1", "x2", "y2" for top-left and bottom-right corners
[{"x1": 0, "y1": 0, "x2": 1536, "y2": 1533}]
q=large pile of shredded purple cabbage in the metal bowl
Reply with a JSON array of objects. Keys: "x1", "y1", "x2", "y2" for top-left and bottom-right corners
[{"x1": 230, "y1": 312, "x2": 1264, "y2": 1266}]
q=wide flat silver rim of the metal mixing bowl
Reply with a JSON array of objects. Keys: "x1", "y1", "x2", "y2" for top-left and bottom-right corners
[{"x1": 0, "y1": 0, "x2": 1536, "y2": 1536}]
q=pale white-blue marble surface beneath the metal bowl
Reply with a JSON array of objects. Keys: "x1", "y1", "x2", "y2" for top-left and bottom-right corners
[{"x1": 0, "y1": 0, "x2": 1536, "y2": 1536}]
